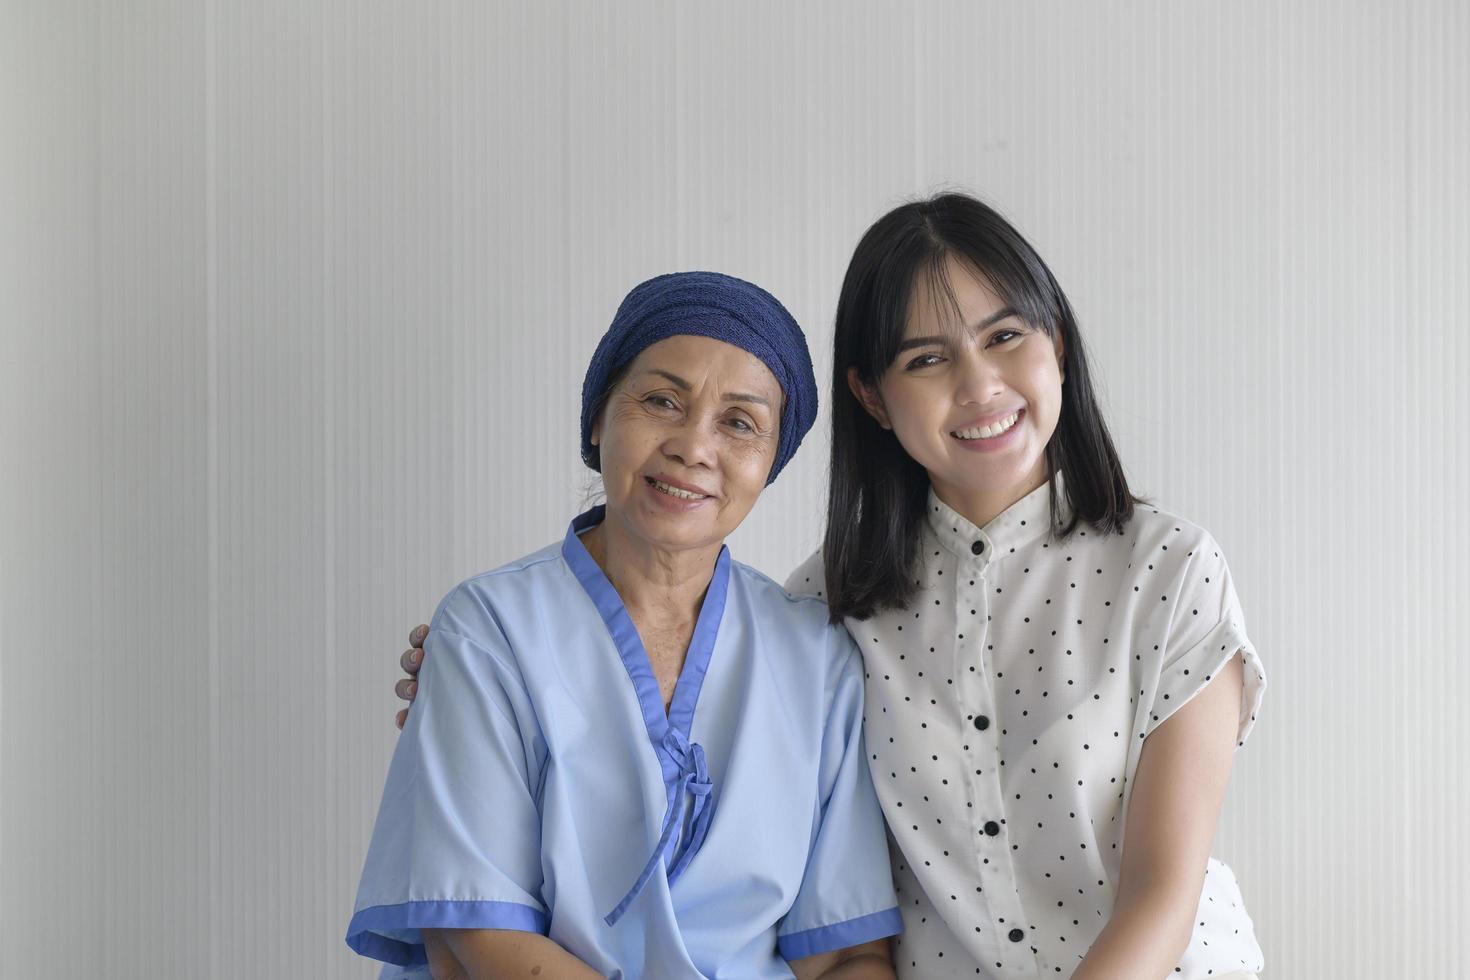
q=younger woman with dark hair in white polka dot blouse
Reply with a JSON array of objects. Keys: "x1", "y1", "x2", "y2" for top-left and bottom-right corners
[{"x1": 400, "y1": 194, "x2": 1266, "y2": 980}]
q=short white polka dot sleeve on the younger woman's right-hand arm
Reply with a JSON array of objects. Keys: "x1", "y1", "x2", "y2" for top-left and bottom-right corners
[{"x1": 1144, "y1": 532, "x2": 1266, "y2": 745}]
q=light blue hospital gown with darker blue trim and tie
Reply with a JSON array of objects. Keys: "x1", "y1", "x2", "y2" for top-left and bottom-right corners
[{"x1": 347, "y1": 508, "x2": 901, "y2": 979}]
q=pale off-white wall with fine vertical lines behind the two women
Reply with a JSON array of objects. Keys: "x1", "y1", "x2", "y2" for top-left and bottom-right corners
[{"x1": 0, "y1": 0, "x2": 1470, "y2": 979}]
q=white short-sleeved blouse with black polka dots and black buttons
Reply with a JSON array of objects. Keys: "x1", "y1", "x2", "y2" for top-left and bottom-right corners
[{"x1": 786, "y1": 473, "x2": 1266, "y2": 980}]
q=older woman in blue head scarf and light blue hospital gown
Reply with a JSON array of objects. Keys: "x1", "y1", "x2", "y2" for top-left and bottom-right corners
[{"x1": 347, "y1": 273, "x2": 901, "y2": 980}]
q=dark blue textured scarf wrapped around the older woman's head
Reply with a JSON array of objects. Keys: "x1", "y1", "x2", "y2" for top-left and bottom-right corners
[{"x1": 582, "y1": 272, "x2": 817, "y2": 485}]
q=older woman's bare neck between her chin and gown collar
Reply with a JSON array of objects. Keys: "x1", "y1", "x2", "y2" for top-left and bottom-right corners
[{"x1": 582, "y1": 513, "x2": 722, "y2": 621}]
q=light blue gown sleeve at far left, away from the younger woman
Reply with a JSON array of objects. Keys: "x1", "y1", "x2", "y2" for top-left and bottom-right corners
[{"x1": 347, "y1": 586, "x2": 548, "y2": 976}]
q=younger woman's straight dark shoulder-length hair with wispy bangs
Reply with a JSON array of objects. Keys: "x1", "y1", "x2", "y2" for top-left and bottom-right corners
[{"x1": 823, "y1": 194, "x2": 1136, "y2": 621}]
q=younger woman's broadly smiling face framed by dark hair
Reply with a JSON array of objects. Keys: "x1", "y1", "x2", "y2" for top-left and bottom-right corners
[{"x1": 850, "y1": 256, "x2": 1063, "y2": 522}]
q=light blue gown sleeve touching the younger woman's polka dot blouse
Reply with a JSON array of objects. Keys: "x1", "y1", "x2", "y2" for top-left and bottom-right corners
[{"x1": 776, "y1": 629, "x2": 903, "y2": 961}]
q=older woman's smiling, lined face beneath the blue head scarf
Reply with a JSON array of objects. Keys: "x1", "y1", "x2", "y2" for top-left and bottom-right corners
[{"x1": 592, "y1": 336, "x2": 782, "y2": 550}]
